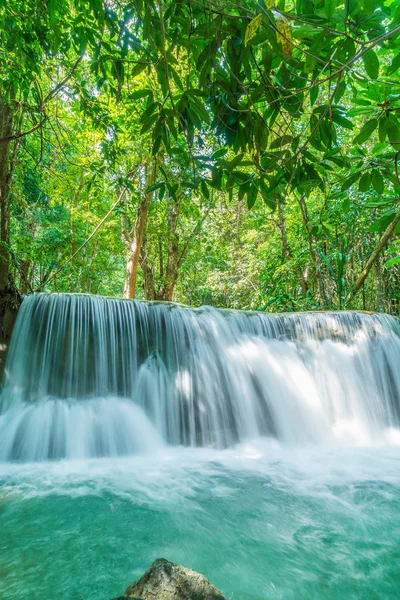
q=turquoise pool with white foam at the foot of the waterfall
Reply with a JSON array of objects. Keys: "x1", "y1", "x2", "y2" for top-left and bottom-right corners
[{"x1": 0, "y1": 441, "x2": 400, "y2": 600}]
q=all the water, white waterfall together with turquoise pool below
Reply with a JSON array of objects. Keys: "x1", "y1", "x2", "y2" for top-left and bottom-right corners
[{"x1": 0, "y1": 294, "x2": 400, "y2": 600}]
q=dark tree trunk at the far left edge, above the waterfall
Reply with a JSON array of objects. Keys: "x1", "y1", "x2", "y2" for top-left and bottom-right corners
[{"x1": 0, "y1": 98, "x2": 12, "y2": 293}]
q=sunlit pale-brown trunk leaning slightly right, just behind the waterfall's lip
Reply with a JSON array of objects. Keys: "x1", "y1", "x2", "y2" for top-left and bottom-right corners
[{"x1": 123, "y1": 165, "x2": 156, "y2": 299}]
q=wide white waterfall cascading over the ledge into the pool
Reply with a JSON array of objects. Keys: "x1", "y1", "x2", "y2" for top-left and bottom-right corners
[{"x1": 0, "y1": 294, "x2": 400, "y2": 461}]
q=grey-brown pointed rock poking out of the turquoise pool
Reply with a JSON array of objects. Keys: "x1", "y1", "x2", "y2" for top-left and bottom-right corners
[{"x1": 122, "y1": 558, "x2": 226, "y2": 600}]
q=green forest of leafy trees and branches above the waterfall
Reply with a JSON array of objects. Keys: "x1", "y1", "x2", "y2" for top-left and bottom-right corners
[{"x1": 0, "y1": 0, "x2": 400, "y2": 313}]
